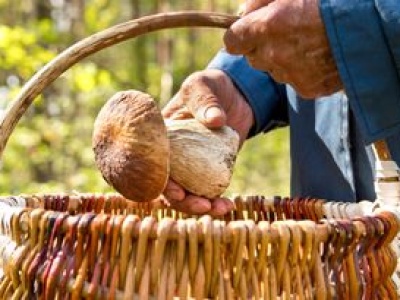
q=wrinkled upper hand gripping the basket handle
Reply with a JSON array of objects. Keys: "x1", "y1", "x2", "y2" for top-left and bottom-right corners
[{"x1": 224, "y1": 0, "x2": 342, "y2": 98}]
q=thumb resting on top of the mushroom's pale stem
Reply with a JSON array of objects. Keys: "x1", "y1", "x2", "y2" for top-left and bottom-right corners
[{"x1": 181, "y1": 75, "x2": 226, "y2": 128}]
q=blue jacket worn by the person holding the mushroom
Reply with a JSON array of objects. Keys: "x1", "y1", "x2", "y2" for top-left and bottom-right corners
[{"x1": 209, "y1": 0, "x2": 400, "y2": 202}]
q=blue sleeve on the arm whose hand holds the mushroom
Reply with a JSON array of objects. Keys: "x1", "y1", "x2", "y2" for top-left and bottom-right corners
[{"x1": 208, "y1": 50, "x2": 288, "y2": 137}]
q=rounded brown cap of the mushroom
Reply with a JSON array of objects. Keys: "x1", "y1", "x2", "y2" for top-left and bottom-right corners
[{"x1": 92, "y1": 90, "x2": 169, "y2": 202}]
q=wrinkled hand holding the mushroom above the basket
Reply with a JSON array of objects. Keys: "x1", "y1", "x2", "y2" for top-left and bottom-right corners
[{"x1": 162, "y1": 70, "x2": 254, "y2": 216}]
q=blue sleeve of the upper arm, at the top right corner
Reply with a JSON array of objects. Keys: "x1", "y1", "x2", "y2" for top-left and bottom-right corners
[{"x1": 320, "y1": 0, "x2": 400, "y2": 143}]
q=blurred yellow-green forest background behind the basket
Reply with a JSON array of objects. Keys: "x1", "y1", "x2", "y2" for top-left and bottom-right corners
[{"x1": 0, "y1": 0, "x2": 290, "y2": 196}]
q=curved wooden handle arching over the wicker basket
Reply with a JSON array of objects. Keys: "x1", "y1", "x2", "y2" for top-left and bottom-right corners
[{"x1": 0, "y1": 11, "x2": 390, "y2": 160}]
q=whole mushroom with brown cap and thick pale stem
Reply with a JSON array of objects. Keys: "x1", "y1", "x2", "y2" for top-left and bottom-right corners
[{"x1": 93, "y1": 90, "x2": 239, "y2": 201}]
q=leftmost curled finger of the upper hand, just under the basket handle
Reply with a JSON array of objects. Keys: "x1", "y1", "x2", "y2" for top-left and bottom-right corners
[{"x1": 224, "y1": 12, "x2": 259, "y2": 55}]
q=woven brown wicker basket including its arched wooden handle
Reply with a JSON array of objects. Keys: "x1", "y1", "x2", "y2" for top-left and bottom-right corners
[{"x1": 0, "y1": 12, "x2": 400, "y2": 300}]
